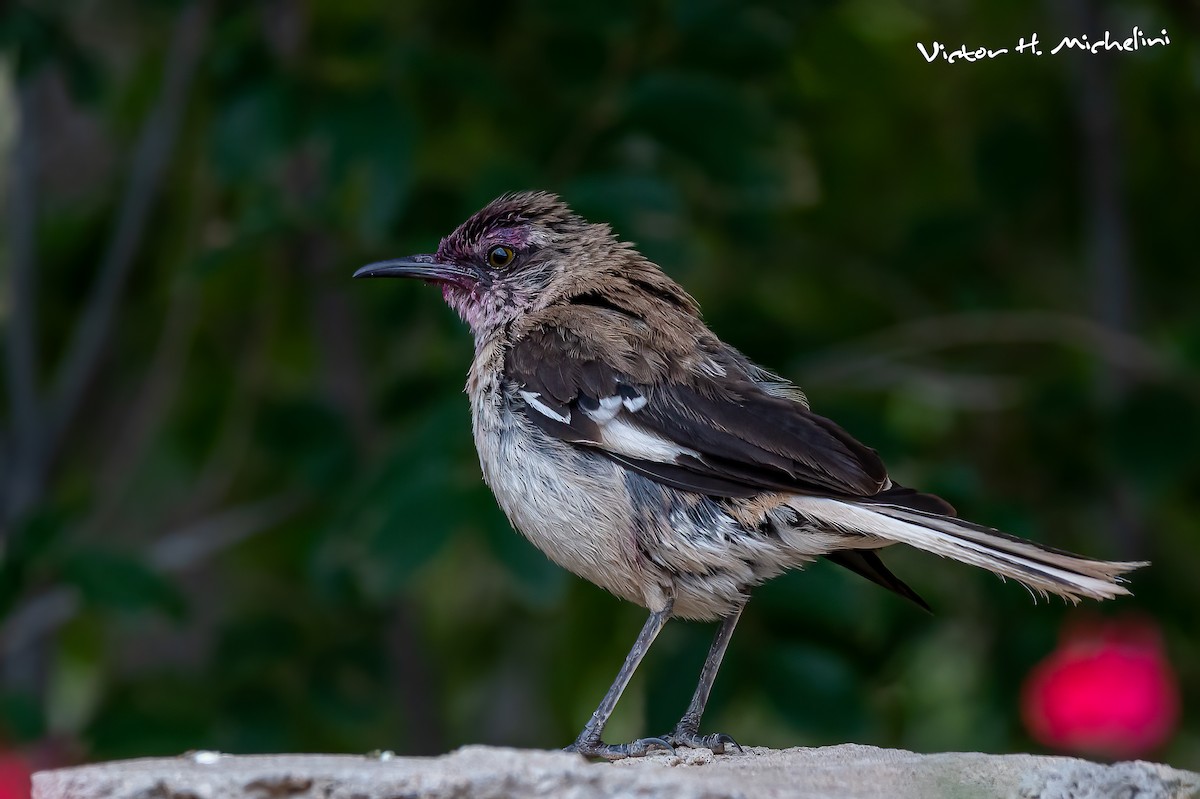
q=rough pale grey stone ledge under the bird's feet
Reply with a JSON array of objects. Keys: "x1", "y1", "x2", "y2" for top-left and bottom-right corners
[{"x1": 34, "y1": 744, "x2": 1200, "y2": 799}]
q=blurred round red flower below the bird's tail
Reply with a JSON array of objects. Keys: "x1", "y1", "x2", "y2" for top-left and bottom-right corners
[{"x1": 1021, "y1": 619, "x2": 1180, "y2": 758}]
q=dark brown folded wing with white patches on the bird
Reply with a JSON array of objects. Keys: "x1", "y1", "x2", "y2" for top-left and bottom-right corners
[{"x1": 504, "y1": 307, "x2": 892, "y2": 498}]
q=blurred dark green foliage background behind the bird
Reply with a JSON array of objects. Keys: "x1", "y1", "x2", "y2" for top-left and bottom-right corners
[{"x1": 0, "y1": 0, "x2": 1200, "y2": 768}]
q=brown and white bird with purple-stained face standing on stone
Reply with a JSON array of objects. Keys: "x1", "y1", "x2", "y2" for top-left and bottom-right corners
[{"x1": 354, "y1": 192, "x2": 1146, "y2": 761}]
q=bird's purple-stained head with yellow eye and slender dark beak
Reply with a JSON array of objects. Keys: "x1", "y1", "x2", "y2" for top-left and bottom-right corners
[{"x1": 354, "y1": 192, "x2": 619, "y2": 338}]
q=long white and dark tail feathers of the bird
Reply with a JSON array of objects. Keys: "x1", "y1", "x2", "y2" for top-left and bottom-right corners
[{"x1": 787, "y1": 497, "x2": 1146, "y2": 602}]
